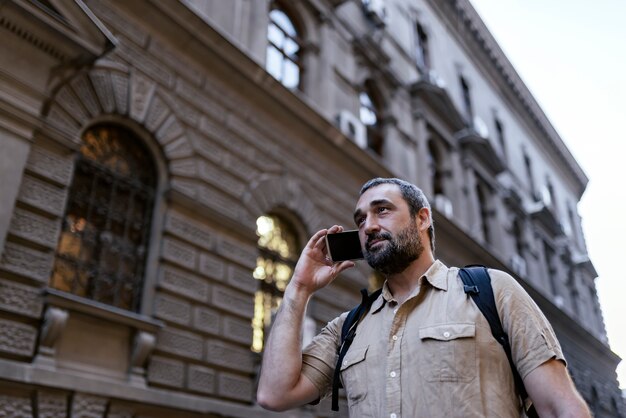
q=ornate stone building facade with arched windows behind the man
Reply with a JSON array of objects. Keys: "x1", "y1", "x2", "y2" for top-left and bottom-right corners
[{"x1": 0, "y1": 0, "x2": 626, "y2": 418}]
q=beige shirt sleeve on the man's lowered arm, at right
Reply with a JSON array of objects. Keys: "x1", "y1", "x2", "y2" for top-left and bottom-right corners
[{"x1": 489, "y1": 270, "x2": 565, "y2": 379}]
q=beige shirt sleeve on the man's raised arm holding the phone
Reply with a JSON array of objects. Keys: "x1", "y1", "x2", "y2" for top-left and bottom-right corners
[{"x1": 302, "y1": 312, "x2": 348, "y2": 398}]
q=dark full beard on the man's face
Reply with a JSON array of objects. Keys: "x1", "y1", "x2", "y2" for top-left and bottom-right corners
[{"x1": 364, "y1": 222, "x2": 424, "y2": 276}]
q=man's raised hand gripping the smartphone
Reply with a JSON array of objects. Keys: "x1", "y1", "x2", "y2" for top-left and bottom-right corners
[{"x1": 290, "y1": 225, "x2": 354, "y2": 295}]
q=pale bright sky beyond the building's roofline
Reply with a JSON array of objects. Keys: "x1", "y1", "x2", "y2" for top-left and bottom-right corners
[{"x1": 470, "y1": 0, "x2": 626, "y2": 389}]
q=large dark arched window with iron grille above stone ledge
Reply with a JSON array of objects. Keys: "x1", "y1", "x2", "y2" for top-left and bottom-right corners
[{"x1": 50, "y1": 124, "x2": 157, "y2": 311}]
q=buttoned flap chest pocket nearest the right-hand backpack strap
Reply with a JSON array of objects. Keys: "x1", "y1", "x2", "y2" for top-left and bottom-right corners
[{"x1": 417, "y1": 323, "x2": 477, "y2": 382}]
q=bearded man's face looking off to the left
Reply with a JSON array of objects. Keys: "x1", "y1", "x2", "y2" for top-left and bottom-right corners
[{"x1": 354, "y1": 184, "x2": 424, "y2": 275}]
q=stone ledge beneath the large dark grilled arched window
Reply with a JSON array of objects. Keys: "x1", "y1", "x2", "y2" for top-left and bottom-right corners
[{"x1": 44, "y1": 289, "x2": 165, "y2": 333}]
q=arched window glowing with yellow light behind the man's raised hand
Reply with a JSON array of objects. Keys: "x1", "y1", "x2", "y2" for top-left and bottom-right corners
[{"x1": 252, "y1": 215, "x2": 300, "y2": 353}]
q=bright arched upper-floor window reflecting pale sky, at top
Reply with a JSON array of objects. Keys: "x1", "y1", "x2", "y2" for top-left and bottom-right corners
[{"x1": 265, "y1": 3, "x2": 302, "y2": 89}]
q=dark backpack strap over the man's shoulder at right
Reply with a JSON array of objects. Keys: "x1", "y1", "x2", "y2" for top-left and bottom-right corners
[{"x1": 459, "y1": 265, "x2": 538, "y2": 418}]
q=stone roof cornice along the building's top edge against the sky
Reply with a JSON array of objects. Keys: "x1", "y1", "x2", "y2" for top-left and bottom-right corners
[{"x1": 428, "y1": 0, "x2": 589, "y2": 196}]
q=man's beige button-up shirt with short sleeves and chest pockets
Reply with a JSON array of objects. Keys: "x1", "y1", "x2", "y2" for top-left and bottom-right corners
[{"x1": 302, "y1": 261, "x2": 564, "y2": 418}]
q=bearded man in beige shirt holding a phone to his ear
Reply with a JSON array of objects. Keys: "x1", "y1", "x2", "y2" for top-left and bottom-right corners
[{"x1": 257, "y1": 178, "x2": 590, "y2": 418}]
